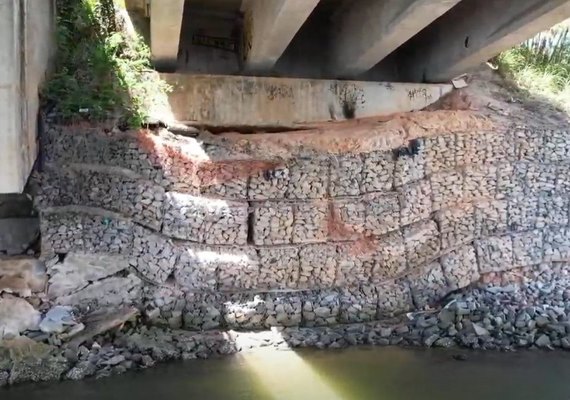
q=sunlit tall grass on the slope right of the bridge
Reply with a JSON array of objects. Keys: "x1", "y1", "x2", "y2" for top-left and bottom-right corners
[{"x1": 495, "y1": 22, "x2": 570, "y2": 111}]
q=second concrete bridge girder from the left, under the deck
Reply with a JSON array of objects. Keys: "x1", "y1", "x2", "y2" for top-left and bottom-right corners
[{"x1": 242, "y1": 0, "x2": 319, "y2": 73}]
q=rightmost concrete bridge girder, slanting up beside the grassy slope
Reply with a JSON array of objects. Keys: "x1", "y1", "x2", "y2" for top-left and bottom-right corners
[{"x1": 400, "y1": 0, "x2": 570, "y2": 82}]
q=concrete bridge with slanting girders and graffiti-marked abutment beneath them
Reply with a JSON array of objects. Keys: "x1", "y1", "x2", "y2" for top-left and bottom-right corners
[{"x1": 138, "y1": 0, "x2": 570, "y2": 129}]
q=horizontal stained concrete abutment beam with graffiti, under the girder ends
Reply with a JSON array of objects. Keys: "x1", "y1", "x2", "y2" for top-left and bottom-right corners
[{"x1": 161, "y1": 74, "x2": 452, "y2": 128}]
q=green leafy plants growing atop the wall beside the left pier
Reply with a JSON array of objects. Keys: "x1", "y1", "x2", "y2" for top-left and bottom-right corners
[{"x1": 42, "y1": 0, "x2": 169, "y2": 127}]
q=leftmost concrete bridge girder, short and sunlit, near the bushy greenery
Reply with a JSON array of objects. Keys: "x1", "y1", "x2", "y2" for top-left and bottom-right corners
[{"x1": 150, "y1": 0, "x2": 185, "y2": 71}]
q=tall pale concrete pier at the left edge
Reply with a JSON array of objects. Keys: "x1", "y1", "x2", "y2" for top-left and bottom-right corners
[{"x1": 0, "y1": 0, "x2": 55, "y2": 194}]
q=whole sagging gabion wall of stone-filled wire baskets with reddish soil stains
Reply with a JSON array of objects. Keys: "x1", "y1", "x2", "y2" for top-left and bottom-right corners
[{"x1": 39, "y1": 128, "x2": 570, "y2": 329}]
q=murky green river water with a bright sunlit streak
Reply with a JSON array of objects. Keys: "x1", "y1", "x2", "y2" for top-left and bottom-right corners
[{"x1": 0, "y1": 347, "x2": 570, "y2": 400}]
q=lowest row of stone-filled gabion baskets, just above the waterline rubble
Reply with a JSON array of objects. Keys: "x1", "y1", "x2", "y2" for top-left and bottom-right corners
[{"x1": 143, "y1": 286, "x2": 406, "y2": 330}]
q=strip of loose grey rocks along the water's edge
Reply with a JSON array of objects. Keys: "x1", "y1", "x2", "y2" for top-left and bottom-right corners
[{"x1": 0, "y1": 264, "x2": 570, "y2": 386}]
